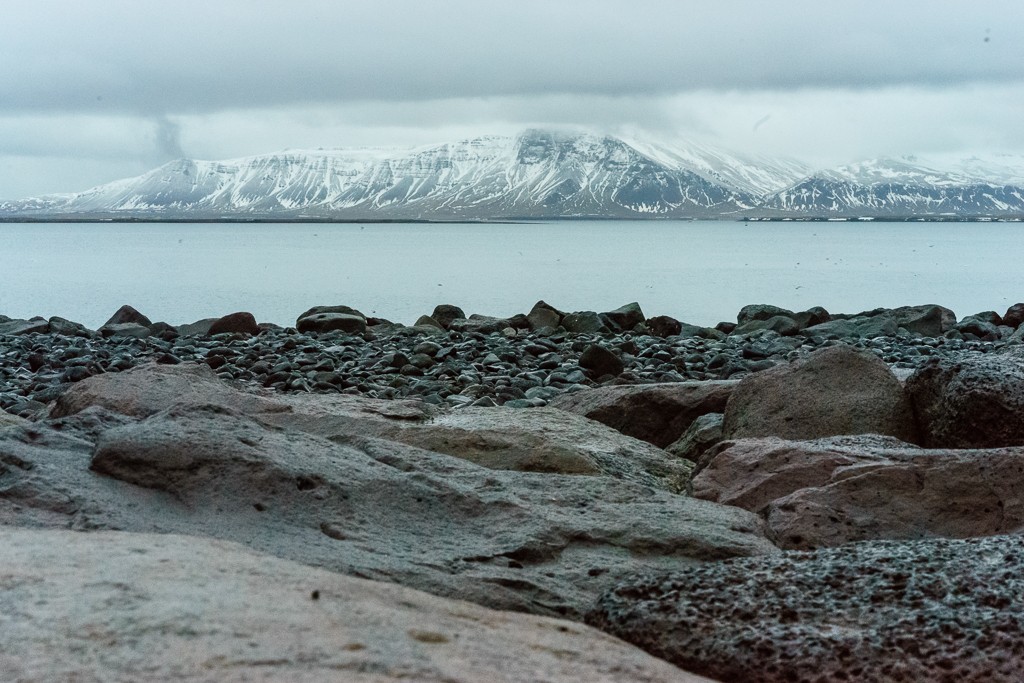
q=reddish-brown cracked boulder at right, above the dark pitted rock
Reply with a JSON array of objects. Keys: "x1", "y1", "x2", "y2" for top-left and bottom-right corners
[{"x1": 693, "y1": 436, "x2": 1024, "y2": 549}]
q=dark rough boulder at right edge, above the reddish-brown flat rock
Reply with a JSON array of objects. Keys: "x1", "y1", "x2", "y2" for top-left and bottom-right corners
[{"x1": 906, "y1": 354, "x2": 1024, "y2": 449}]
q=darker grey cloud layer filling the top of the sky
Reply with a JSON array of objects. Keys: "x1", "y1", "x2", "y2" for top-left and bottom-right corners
[{"x1": 0, "y1": 0, "x2": 1024, "y2": 114}]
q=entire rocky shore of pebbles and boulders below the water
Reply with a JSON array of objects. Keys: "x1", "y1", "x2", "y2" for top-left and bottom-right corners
[{"x1": 6, "y1": 302, "x2": 1024, "y2": 682}]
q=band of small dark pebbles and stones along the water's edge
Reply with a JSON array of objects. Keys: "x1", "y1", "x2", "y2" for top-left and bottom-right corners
[{"x1": 0, "y1": 301, "x2": 1024, "y2": 417}]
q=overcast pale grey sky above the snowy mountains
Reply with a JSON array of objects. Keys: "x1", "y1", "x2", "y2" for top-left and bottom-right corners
[{"x1": 0, "y1": 0, "x2": 1024, "y2": 199}]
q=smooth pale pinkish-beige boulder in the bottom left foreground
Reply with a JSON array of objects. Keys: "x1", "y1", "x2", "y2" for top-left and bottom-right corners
[{"x1": 0, "y1": 528, "x2": 706, "y2": 683}]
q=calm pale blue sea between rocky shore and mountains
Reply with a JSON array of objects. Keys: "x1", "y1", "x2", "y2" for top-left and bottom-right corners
[{"x1": 0, "y1": 221, "x2": 1024, "y2": 328}]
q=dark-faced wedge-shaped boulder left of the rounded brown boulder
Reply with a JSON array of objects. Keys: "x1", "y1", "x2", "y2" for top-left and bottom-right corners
[{"x1": 548, "y1": 380, "x2": 737, "y2": 449}]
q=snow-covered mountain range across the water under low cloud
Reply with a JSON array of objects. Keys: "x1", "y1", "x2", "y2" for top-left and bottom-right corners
[{"x1": 0, "y1": 130, "x2": 1024, "y2": 220}]
